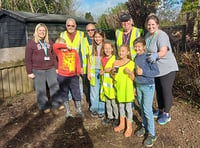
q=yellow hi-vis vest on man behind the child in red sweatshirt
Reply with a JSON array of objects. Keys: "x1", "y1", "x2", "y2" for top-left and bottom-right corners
[{"x1": 60, "y1": 30, "x2": 84, "y2": 53}]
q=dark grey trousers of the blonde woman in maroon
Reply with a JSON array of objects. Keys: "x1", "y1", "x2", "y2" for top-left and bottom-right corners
[{"x1": 33, "y1": 68, "x2": 62, "y2": 111}]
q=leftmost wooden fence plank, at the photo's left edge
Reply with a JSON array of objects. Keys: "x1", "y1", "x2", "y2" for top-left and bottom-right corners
[{"x1": 2, "y1": 69, "x2": 10, "y2": 98}]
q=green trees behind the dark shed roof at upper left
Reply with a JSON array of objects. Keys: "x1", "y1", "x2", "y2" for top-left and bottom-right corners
[{"x1": 0, "y1": 0, "x2": 78, "y2": 15}]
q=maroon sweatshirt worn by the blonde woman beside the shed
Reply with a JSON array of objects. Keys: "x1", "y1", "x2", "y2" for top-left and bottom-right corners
[{"x1": 25, "y1": 39, "x2": 58, "y2": 74}]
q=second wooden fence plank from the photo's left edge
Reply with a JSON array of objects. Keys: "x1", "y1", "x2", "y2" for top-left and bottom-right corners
[{"x1": 8, "y1": 68, "x2": 17, "y2": 97}]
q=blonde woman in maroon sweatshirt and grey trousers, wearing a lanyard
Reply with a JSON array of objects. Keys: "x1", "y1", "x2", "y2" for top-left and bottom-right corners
[{"x1": 25, "y1": 23, "x2": 62, "y2": 113}]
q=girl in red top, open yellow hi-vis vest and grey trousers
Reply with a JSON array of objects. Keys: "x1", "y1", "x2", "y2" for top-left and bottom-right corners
[{"x1": 100, "y1": 41, "x2": 119, "y2": 127}]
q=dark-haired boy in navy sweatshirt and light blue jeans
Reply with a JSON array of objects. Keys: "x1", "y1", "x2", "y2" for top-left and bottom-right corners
[{"x1": 134, "y1": 37, "x2": 159, "y2": 147}]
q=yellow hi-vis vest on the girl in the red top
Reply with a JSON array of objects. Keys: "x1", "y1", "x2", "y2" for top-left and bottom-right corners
[{"x1": 100, "y1": 55, "x2": 116, "y2": 102}]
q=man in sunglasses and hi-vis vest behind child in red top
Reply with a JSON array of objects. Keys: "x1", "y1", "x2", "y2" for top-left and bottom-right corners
[{"x1": 60, "y1": 18, "x2": 84, "y2": 99}]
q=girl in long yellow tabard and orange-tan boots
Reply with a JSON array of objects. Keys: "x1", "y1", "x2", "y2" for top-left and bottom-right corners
[{"x1": 114, "y1": 45, "x2": 135, "y2": 137}]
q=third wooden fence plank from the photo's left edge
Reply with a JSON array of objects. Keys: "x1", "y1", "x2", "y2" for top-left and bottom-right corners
[{"x1": 15, "y1": 67, "x2": 22, "y2": 94}]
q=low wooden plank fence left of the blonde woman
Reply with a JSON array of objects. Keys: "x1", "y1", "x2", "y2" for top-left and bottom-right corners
[{"x1": 0, "y1": 62, "x2": 34, "y2": 99}]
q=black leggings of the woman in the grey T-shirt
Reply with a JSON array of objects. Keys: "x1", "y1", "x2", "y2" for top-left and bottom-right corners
[{"x1": 155, "y1": 71, "x2": 176, "y2": 113}]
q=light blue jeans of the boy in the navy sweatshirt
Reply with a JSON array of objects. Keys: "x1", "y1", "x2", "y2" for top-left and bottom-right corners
[{"x1": 136, "y1": 84, "x2": 155, "y2": 136}]
